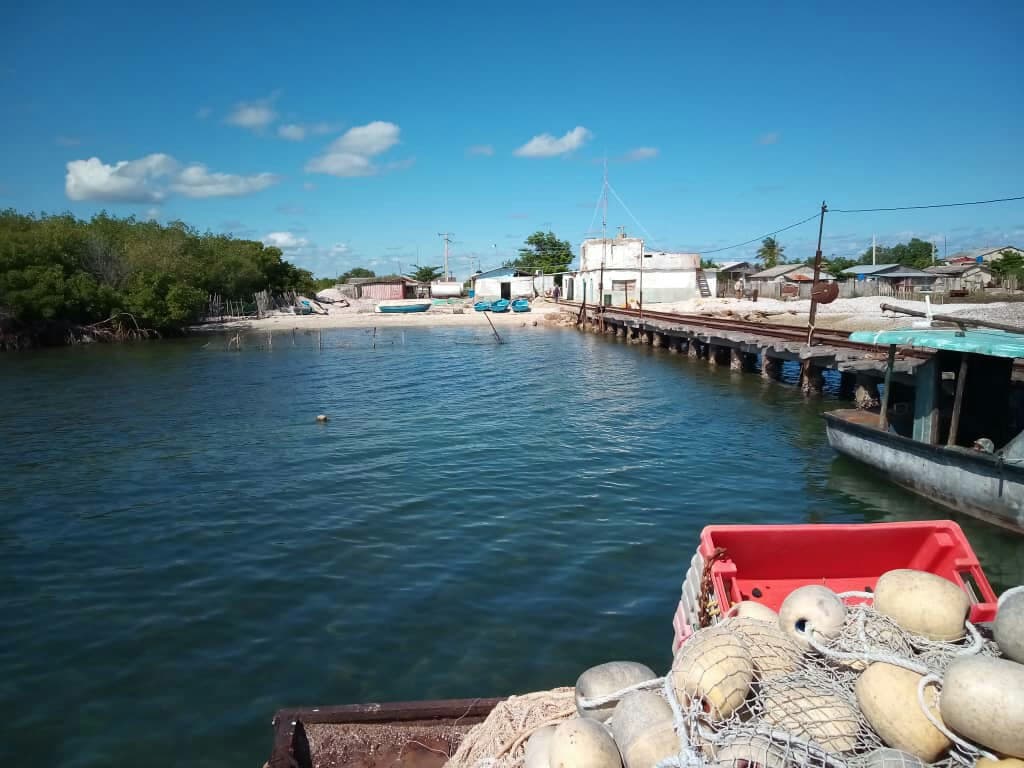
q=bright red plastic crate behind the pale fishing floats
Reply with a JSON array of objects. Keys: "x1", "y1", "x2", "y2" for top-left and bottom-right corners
[{"x1": 699, "y1": 520, "x2": 996, "y2": 624}]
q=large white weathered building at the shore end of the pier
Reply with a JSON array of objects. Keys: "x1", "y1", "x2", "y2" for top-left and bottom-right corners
[{"x1": 562, "y1": 233, "x2": 716, "y2": 306}]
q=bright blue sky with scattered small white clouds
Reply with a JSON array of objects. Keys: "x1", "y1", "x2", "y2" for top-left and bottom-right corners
[{"x1": 0, "y1": 0, "x2": 1024, "y2": 275}]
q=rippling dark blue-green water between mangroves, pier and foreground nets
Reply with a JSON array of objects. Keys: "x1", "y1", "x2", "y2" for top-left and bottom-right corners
[{"x1": 0, "y1": 328, "x2": 1024, "y2": 766}]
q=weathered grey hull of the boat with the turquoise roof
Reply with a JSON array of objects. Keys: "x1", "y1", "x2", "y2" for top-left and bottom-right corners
[{"x1": 824, "y1": 409, "x2": 1024, "y2": 532}]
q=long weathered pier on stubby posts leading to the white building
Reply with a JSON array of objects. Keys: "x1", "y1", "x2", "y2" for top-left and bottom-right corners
[{"x1": 578, "y1": 306, "x2": 931, "y2": 399}]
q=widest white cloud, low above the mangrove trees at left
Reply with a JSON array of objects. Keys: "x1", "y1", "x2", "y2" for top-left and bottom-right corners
[{"x1": 65, "y1": 153, "x2": 280, "y2": 203}]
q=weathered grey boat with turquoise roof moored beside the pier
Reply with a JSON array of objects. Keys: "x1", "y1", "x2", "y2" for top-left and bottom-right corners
[{"x1": 824, "y1": 328, "x2": 1024, "y2": 532}]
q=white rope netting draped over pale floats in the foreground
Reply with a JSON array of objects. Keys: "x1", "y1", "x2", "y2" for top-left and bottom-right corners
[{"x1": 449, "y1": 593, "x2": 999, "y2": 768}]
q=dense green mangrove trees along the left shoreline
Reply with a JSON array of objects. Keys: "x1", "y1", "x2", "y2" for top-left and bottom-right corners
[{"x1": 0, "y1": 209, "x2": 314, "y2": 344}]
